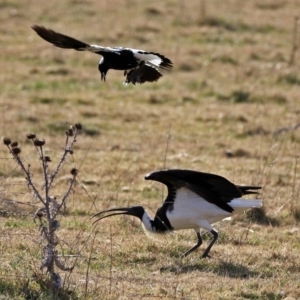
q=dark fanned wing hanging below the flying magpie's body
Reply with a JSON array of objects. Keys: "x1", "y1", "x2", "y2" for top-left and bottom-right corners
[{"x1": 124, "y1": 63, "x2": 162, "y2": 85}]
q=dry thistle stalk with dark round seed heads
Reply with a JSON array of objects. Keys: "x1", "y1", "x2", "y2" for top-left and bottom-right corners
[{"x1": 3, "y1": 123, "x2": 82, "y2": 298}]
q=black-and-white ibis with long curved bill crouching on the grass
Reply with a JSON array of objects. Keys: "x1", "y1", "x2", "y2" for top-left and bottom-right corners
[{"x1": 93, "y1": 169, "x2": 262, "y2": 257}]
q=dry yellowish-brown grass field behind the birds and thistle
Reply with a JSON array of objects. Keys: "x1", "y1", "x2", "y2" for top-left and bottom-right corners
[{"x1": 0, "y1": 0, "x2": 300, "y2": 300}]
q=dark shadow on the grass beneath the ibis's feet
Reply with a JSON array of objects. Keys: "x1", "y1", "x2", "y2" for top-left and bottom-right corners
[{"x1": 160, "y1": 260, "x2": 260, "y2": 279}]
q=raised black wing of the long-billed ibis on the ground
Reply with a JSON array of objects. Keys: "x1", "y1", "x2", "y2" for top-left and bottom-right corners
[{"x1": 145, "y1": 169, "x2": 259, "y2": 212}]
